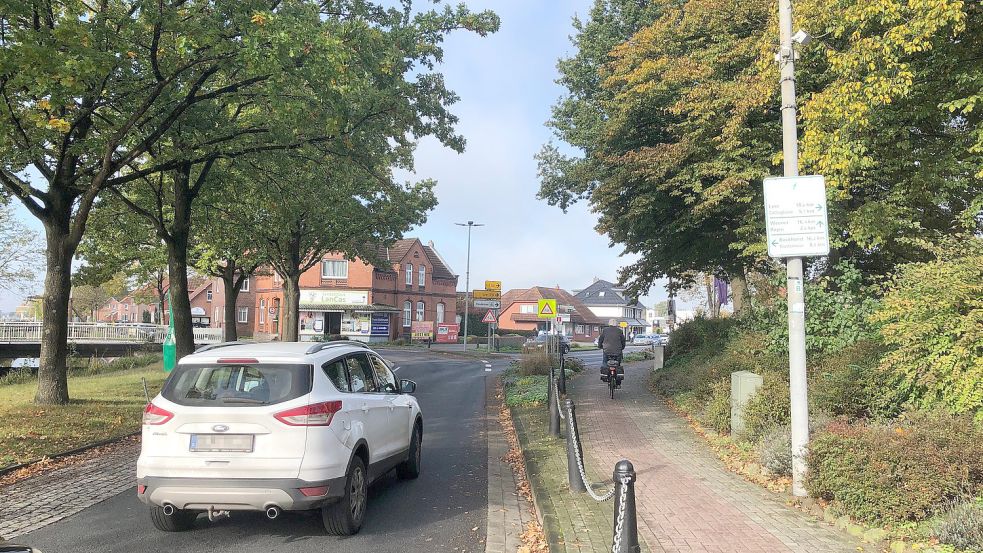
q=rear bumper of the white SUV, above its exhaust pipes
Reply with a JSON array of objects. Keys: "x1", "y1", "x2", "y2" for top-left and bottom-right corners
[{"x1": 137, "y1": 476, "x2": 345, "y2": 511}]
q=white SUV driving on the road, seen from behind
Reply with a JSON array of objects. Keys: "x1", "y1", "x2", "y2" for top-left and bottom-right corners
[{"x1": 137, "y1": 342, "x2": 423, "y2": 535}]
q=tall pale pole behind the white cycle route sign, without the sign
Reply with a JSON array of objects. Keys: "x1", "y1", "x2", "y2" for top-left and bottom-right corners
[{"x1": 777, "y1": 0, "x2": 809, "y2": 497}]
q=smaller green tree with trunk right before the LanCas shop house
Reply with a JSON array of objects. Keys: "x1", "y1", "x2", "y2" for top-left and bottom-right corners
[{"x1": 229, "y1": 150, "x2": 436, "y2": 341}]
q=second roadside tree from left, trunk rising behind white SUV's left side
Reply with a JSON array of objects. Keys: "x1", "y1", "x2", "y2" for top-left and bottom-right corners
[{"x1": 112, "y1": 2, "x2": 498, "y2": 358}]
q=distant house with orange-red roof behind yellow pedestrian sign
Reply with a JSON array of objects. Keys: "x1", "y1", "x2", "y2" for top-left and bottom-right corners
[{"x1": 498, "y1": 286, "x2": 602, "y2": 342}]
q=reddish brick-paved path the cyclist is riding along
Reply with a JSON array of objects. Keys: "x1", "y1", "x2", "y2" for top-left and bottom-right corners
[{"x1": 567, "y1": 363, "x2": 859, "y2": 553}]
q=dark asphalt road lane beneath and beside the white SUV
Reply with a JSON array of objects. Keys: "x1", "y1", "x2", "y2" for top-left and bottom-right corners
[{"x1": 18, "y1": 351, "x2": 498, "y2": 553}]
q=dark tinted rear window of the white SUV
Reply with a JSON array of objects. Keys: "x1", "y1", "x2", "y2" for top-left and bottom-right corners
[{"x1": 161, "y1": 364, "x2": 314, "y2": 407}]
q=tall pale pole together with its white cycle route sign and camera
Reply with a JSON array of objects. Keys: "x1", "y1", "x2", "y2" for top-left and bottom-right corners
[{"x1": 764, "y1": 0, "x2": 829, "y2": 497}]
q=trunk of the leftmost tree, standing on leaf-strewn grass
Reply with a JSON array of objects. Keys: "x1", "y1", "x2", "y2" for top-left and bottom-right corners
[{"x1": 34, "y1": 221, "x2": 77, "y2": 405}]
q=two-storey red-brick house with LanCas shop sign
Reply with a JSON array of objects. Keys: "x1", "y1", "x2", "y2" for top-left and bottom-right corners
[{"x1": 251, "y1": 238, "x2": 457, "y2": 342}]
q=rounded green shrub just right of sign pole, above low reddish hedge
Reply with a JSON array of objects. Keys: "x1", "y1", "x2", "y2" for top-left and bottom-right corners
[{"x1": 809, "y1": 340, "x2": 899, "y2": 419}]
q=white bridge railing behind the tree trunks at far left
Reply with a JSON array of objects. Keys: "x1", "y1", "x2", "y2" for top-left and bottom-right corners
[{"x1": 0, "y1": 321, "x2": 222, "y2": 344}]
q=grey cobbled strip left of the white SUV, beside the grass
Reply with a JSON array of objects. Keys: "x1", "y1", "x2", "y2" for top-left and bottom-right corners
[{"x1": 0, "y1": 439, "x2": 140, "y2": 539}]
